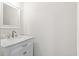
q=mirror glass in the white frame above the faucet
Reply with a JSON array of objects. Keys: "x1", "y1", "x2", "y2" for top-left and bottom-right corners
[{"x1": 3, "y1": 3, "x2": 20, "y2": 25}]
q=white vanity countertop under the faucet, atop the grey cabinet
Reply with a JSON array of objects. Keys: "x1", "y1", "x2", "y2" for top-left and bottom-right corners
[{"x1": 1, "y1": 35, "x2": 32, "y2": 47}]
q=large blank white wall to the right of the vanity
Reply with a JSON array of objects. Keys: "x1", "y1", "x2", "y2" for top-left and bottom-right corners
[{"x1": 23, "y1": 2, "x2": 77, "y2": 56}]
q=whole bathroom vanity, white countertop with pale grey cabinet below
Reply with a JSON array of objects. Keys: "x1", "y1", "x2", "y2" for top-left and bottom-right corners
[{"x1": 0, "y1": 36, "x2": 33, "y2": 56}]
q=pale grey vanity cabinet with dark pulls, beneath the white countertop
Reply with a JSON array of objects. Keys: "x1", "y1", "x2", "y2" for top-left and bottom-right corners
[{"x1": 1, "y1": 38, "x2": 33, "y2": 56}]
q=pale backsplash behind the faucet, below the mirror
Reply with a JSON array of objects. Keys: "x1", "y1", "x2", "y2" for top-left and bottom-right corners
[{"x1": 0, "y1": 28, "x2": 20, "y2": 39}]
